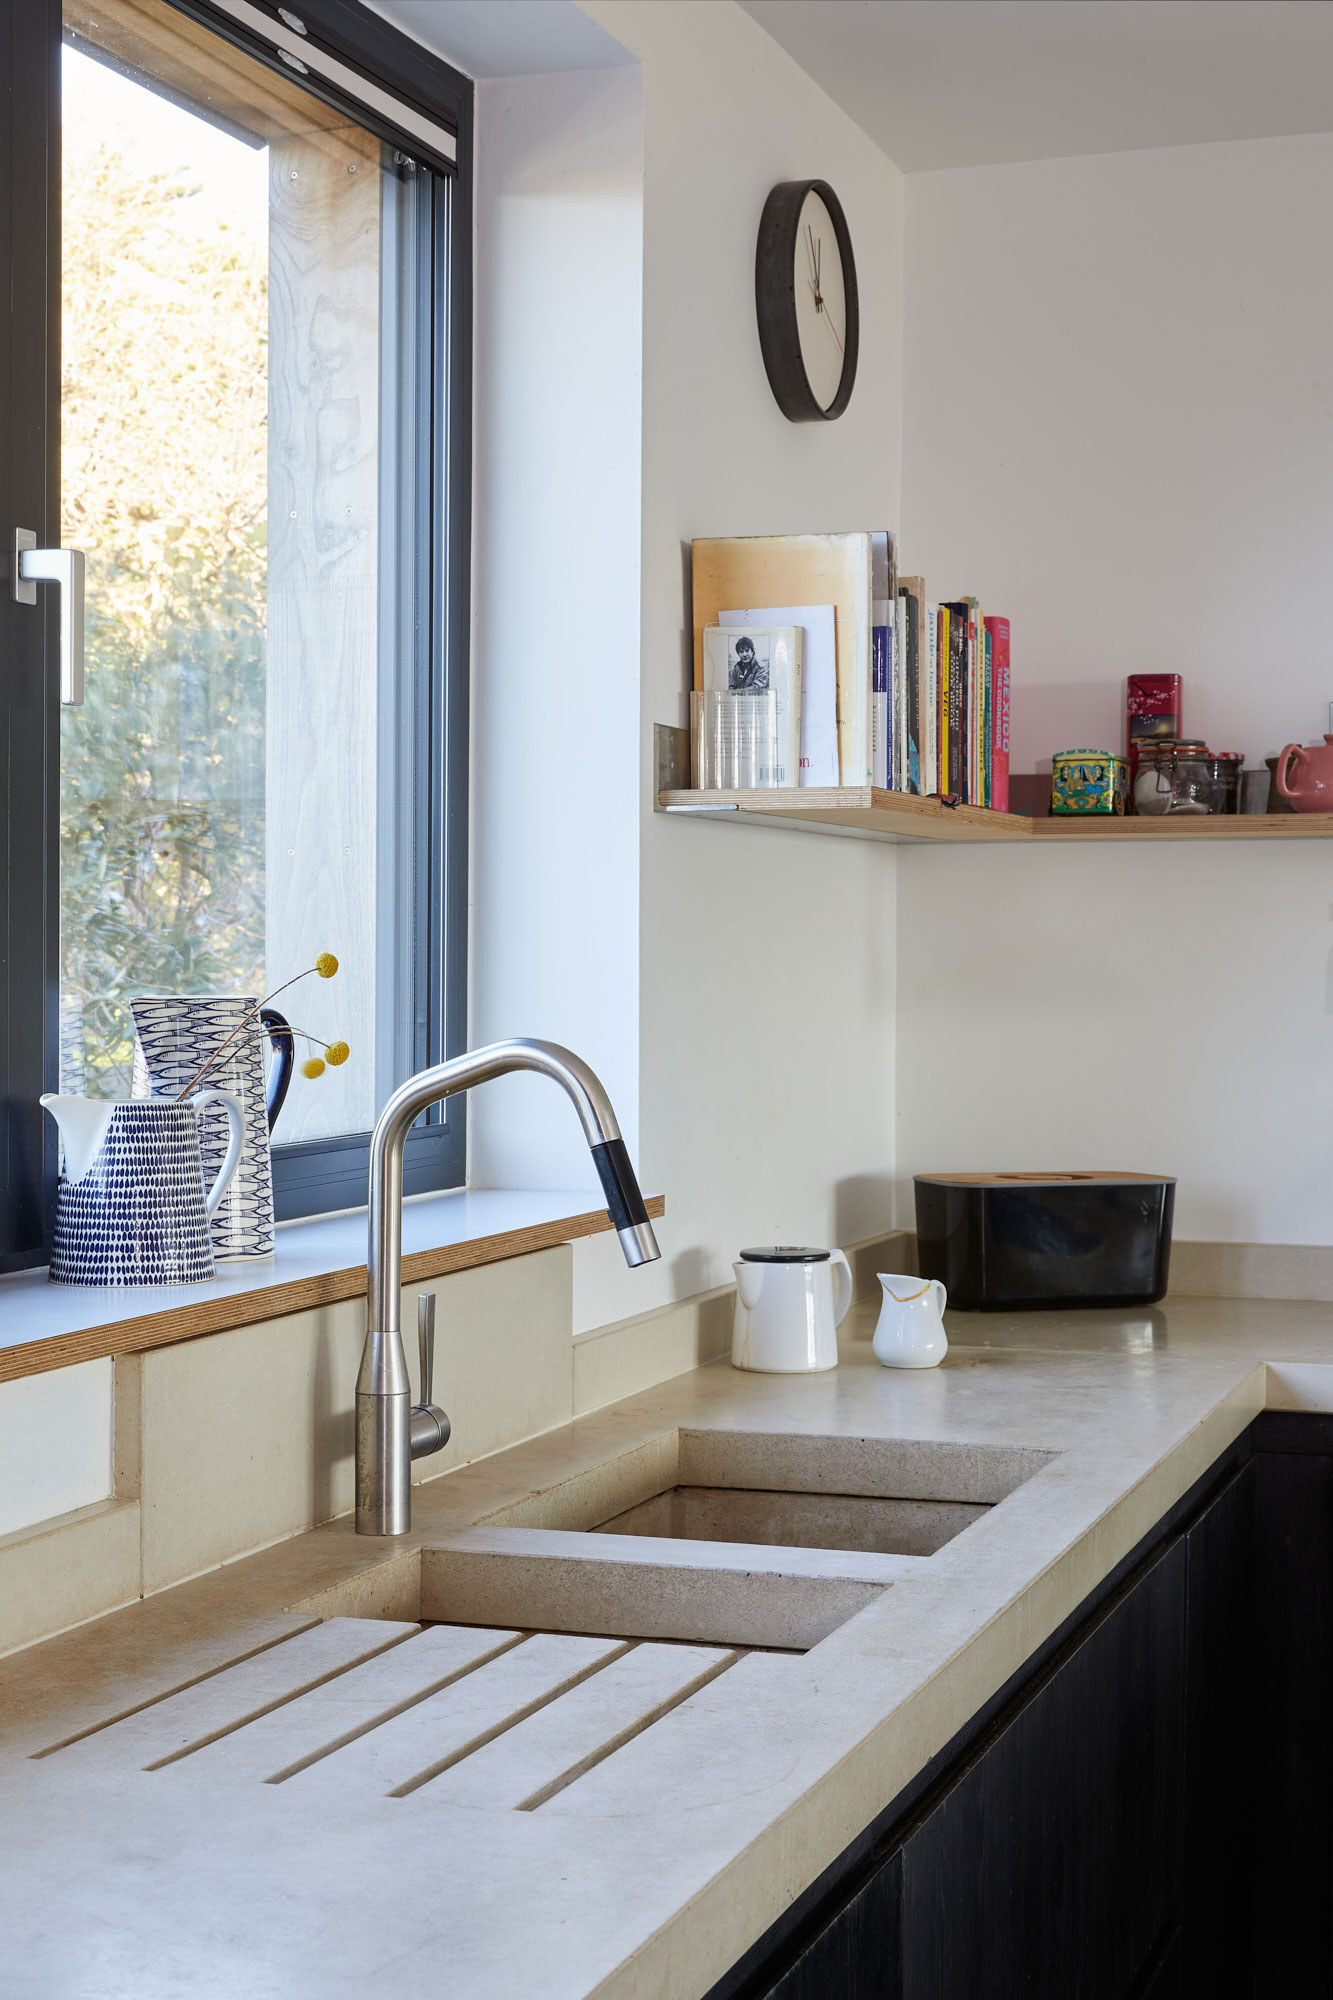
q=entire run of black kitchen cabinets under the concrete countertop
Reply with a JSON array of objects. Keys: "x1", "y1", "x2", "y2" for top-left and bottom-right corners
[{"x1": 709, "y1": 1416, "x2": 1333, "y2": 2000}]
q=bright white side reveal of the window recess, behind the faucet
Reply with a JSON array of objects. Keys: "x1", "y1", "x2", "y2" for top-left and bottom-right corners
[{"x1": 470, "y1": 66, "x2": 642, "y2": 1188}]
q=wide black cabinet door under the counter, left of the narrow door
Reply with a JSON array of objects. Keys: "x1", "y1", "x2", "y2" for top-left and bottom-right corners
[{"x1": 903, "y1": 1540, "x2": 1185, "y2": 2000}]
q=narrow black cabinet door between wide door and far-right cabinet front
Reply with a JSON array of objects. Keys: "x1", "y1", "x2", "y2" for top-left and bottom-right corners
[{"x1": 1179, "y1": 1464, "x2": 1255, "y2": 2000}]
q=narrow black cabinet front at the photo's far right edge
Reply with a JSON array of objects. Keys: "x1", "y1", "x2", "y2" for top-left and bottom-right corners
[{"x1": 1235, "y1": 1450, "x2": 1333, "y2": 2000}]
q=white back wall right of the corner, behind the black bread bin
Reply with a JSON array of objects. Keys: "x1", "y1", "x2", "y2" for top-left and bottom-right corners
[{"x1": 899, "y1": 136, "x2": 1333, "y2": 1244}]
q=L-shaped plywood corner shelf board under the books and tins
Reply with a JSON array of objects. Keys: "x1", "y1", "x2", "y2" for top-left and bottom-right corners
[{"x1": 658, "y1": 784, "x2": 1333, "y2": 844}]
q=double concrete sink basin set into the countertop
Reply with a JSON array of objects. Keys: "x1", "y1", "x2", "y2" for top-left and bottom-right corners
[{"x1": 290, "y1": 1428, "x2": 1051, "y2": 1652}]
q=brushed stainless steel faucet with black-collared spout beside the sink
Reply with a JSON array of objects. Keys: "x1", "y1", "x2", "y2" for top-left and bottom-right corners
[{"x1": 356, "y1": 1042, "x2": 660, "y2": 1534}]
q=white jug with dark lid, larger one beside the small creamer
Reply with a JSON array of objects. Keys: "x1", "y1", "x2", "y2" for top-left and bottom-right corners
[{"x1": 731, "y1": 1244, "x2": 853, "y2": 1374}]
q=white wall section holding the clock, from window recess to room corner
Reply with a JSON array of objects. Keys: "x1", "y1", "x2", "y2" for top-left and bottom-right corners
[{"x1": 572, "y1": 0, "x2": 903, "y2": 1326}]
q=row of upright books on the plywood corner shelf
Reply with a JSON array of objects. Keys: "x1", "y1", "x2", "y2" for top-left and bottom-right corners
[{"x1": 693, "y1": 532, "x2": 1009, "y2": 812}]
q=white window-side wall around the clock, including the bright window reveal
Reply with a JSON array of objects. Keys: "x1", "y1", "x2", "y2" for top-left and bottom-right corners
[{"x1": 410, "y1": 0, "x2": 901, "y2": 1330}]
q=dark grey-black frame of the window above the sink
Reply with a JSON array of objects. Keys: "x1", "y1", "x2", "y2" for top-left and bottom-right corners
[{"x1": 0, "y1": 0, "x2": 472, "y2": 1272}]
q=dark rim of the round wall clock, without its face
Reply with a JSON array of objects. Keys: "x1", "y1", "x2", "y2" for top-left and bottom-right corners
[{"x1": 755, "y1": 180, "x2": 861, "y2": 424}]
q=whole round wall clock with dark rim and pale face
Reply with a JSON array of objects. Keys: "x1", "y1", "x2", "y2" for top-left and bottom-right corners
[{"x1": 755, "y1": 180, "x2": 861, "y2": 424}]
